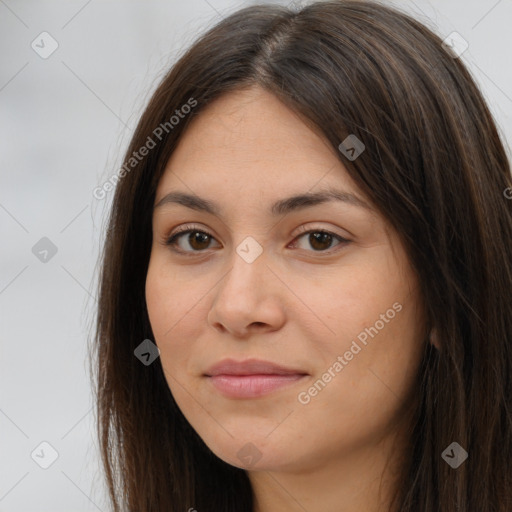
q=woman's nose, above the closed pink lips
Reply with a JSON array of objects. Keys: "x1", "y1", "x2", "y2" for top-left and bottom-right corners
[{"x1": 208, "y1": 246, "x2": 286, "y2": 338}]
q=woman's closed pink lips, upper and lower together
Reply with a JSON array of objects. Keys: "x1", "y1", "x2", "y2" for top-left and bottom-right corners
[{"x1": 205, "y1": 359, "x2": 308, "y2": 398}]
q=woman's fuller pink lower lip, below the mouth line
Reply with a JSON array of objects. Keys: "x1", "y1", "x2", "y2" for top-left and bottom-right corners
[{"x1": 208, "y1": 374, "x2": 306, "y2": 398}]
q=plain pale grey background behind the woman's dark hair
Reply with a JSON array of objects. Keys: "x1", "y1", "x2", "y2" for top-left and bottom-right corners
[{"x1": 0, "y1": 0, "x2": 512, "y2": 512}]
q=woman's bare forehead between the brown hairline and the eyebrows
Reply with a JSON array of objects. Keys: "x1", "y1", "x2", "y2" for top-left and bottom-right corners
[{"x1": 159, "y1": 87, "x2": 357, "y2": 199}]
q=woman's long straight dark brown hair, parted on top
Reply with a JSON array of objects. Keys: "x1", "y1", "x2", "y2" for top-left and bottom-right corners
[{"x1": 92, "y1": 0, "x2": 512, "y2": 512}]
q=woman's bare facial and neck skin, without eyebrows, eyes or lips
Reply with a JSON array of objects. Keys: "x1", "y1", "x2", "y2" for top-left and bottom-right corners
[{"x1": 146, "y1": 87, "x2": 425, "y2": 512}]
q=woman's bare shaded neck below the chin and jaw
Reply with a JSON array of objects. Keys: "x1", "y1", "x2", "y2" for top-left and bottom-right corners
[{"x1": 248, "y1": 424, "x2": 408, "y2": 512}]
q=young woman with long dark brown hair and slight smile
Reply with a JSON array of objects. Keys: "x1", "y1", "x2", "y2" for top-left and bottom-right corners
[{"x1": 95, "y1": 0, "x2": 512, "y2": 512}]
